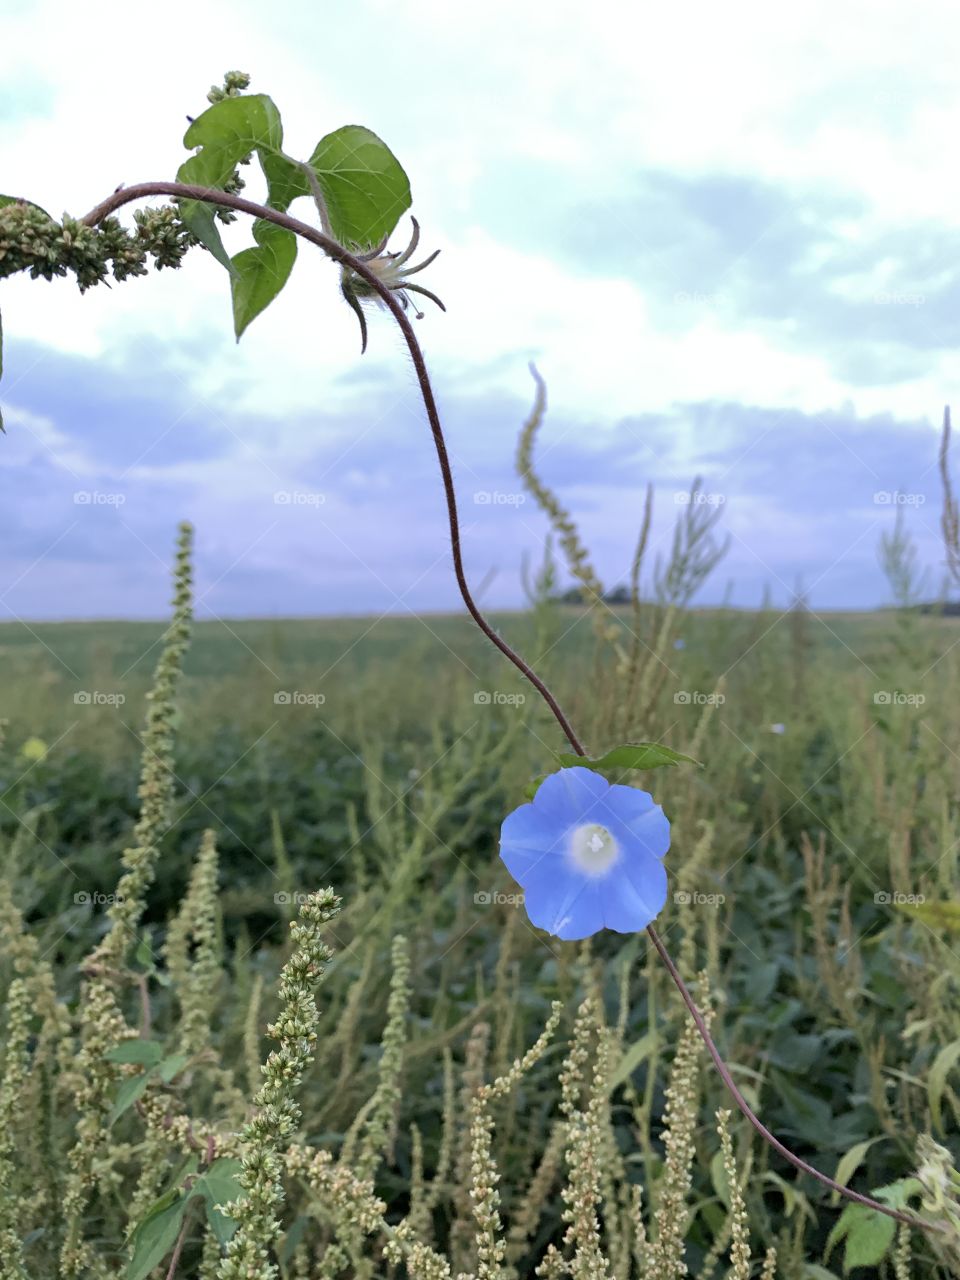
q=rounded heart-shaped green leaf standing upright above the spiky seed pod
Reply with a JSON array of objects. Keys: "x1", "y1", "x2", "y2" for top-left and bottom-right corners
[{"x1": 307, "y1": 124, "x2": 411, "y2": 248}]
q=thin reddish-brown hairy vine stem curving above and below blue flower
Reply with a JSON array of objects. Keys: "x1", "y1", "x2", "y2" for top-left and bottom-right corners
[{"x1": 81, "y1": 182, "x2": 946, "y2": 1231}]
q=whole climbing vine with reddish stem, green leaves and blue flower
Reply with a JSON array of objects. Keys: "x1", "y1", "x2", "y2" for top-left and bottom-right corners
[{"x1": 0, "y1": 72, "x2": 956, "y2": 1275}]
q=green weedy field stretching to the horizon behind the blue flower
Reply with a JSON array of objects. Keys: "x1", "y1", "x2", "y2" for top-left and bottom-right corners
[{"x1": 0, "y1": 602, "x2": 960, "y2": 1277}]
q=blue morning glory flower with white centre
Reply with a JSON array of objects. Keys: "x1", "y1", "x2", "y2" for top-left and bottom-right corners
[{"x1": 500, "y1": 767, "x2": 669, "y2": 938}]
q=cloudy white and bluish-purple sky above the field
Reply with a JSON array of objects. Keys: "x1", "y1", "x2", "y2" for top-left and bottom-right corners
[{"x1": 0, "y1": 0, "x2": 960, "y2": 618}]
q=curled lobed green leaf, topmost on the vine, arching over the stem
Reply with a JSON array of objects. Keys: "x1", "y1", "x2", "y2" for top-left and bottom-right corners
[{"x1": 177, "y1": 93, "x2": 283, "y2": 273}]
